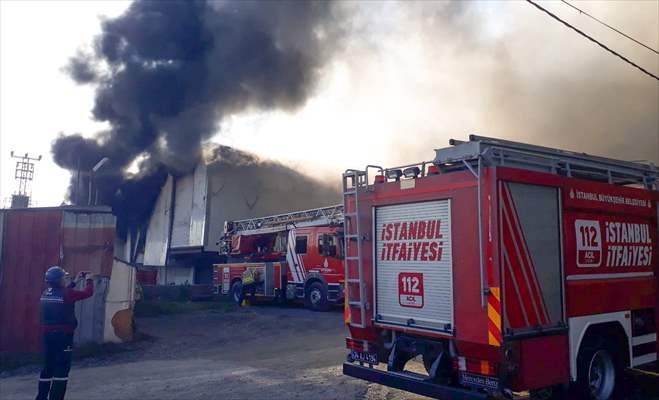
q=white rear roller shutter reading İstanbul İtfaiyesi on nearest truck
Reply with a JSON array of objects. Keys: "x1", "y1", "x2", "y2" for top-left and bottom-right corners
[{"x1": 374, "y1": 199, "x2": 453, "y2": 333}]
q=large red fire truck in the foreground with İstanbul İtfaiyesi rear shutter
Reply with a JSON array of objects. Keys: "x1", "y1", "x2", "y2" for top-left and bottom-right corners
[{"x1": 343, "y1": 136, "x2": 659, "y2": 399}]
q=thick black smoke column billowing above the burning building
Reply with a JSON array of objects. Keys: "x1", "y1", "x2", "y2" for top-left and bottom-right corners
[{"x1": 52, "y1": 0, "x2": 342, "y2": 223}]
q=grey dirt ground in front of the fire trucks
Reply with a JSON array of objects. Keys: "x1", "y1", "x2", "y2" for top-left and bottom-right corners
[{"x1": 0, "y1": 305, "x2": 657, "y2": 400}]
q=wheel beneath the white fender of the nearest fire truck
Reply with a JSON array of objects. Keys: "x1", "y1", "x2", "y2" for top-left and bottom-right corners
[{"x1": 576, "y1": 336, "x2": 623, "y2": 400}]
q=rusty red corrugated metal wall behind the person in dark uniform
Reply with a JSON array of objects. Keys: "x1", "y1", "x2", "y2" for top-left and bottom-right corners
[{"x1": 0, "y1": 207, "x2": 115, "y2": 352}]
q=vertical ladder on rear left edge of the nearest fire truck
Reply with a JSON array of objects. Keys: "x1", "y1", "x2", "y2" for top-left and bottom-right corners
[{"x1": 343, "y1": 169, "x2": 368, "y2": 328}]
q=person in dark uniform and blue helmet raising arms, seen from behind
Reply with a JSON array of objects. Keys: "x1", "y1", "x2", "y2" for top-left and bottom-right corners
[{"x1": 36, "y1": 265, "x2": 94, "y2": 400}]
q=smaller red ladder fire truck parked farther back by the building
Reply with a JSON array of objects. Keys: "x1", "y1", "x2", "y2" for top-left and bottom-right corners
[{"x1": 213, "y1": 205, "x2": 344, "y2": 311}]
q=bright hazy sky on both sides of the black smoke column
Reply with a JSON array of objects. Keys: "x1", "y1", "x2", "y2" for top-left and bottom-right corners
[{"x1": 0, "y1": 0, "x2": 659, "y2": 206}]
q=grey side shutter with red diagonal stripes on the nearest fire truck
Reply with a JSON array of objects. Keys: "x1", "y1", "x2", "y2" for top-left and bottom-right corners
[{"x1": 499, "y1": 182, "x2": 564, "y2": 332}]
